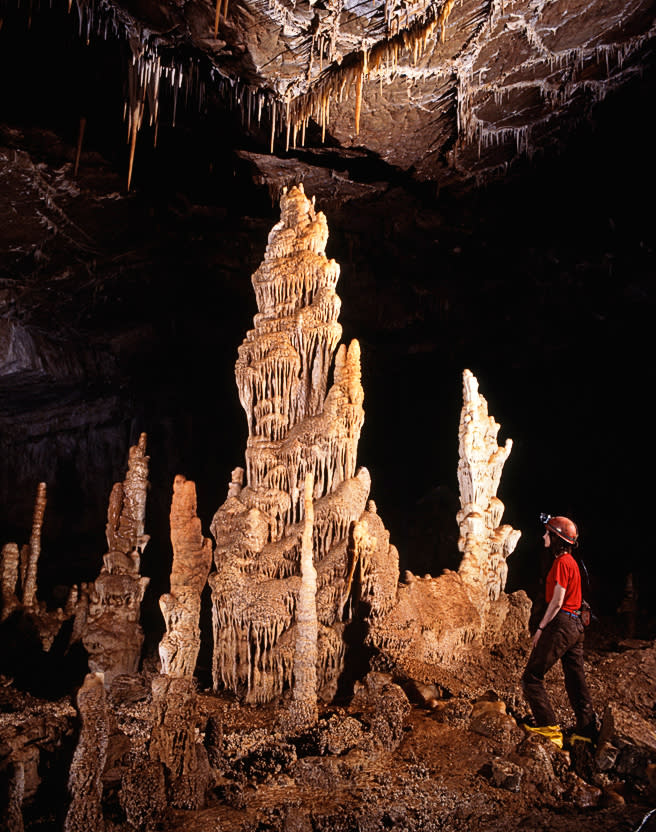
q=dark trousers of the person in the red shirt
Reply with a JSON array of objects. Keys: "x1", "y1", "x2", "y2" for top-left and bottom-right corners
[{"x1": 522, "y1": 610, "x2": 595, "y2": 731}]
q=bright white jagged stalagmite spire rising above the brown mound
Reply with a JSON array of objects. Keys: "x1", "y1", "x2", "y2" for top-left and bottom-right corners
[{"x1": 457, "y1": 370, "x2": 521, "y2": 601}]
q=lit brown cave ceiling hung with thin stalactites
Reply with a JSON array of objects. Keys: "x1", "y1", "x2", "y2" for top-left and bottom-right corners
[{"x1": 5, "y1": 0, "x2": 654, "y2": 191}]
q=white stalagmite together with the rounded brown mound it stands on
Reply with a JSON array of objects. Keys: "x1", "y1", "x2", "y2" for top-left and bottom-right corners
[{"x1": 368, "y1": 370, "x2": 531, "y2": 683}]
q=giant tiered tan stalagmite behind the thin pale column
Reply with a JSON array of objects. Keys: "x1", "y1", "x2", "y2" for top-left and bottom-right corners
[{"x1": 210, "y1": 186, "x2": 396, "y2": 702}]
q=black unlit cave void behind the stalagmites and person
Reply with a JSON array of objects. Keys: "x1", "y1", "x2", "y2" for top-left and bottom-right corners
[{"x1": 0, "y1": 0, "x2": 655, "y2": 664}]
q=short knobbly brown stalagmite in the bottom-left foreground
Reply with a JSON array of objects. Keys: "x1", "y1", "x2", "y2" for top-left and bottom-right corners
[{"x1": 64, "y1": 673, "x2": 110, "y2": 832}]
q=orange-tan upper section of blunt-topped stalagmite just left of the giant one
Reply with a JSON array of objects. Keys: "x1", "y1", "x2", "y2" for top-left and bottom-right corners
[{"x1": 159, "y1": 476, "x2": 212, "y2": 677}]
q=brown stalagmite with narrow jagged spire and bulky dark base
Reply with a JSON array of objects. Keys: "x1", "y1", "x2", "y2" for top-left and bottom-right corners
[{"x1": 80, "y1": 433, "x2": 149, "y2": 687}]
